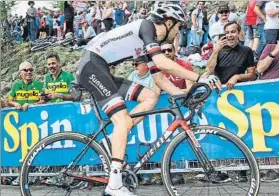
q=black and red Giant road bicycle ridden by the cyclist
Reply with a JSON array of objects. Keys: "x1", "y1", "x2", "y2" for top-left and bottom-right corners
[{"x1": 20, "y1": 83, "x2": 260, "y2": 196}]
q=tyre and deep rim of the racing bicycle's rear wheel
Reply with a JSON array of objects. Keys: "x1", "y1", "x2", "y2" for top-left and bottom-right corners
[{"x1": 20, "y1": 132, "x2": 110, "y2": 196}]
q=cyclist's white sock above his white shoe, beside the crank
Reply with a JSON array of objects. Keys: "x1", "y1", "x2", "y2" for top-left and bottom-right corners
[{"x1": 108, "y1": 161, "x2": 123, "y2": 189}]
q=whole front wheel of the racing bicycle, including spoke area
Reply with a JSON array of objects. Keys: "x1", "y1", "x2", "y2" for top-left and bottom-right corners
[{"x1": 162, "y1": 126, "x2": 260, "y2": 196}]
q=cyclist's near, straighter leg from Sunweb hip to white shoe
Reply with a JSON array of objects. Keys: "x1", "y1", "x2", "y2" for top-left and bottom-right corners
[{"x1": 77, "y1": 52, "x2": 133, "y2": 195}]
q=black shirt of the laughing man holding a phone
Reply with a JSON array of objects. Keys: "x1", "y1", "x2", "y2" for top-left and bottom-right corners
[{"x1": 215, "y1": 45, "x2": 255, "y2": 84}]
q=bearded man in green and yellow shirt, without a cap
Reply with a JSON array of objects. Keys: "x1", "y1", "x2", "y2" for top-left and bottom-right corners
[{"x1": 45, "y1": 53, "x2": 74, "y2": 103}]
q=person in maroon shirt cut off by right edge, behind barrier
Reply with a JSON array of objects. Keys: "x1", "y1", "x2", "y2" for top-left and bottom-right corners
[{"x1": 257, "y1": 41, "x2": 279, "y2": 80}]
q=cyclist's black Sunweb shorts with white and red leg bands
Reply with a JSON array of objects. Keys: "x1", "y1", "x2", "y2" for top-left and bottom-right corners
[{"x1": 77, "y1": 51, "x2": 144, "y2": 118}]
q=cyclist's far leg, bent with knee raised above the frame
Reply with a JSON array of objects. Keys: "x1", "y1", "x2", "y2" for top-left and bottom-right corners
[{"x1": 112, "y1": 76, "x2": 159, "y2": 125}]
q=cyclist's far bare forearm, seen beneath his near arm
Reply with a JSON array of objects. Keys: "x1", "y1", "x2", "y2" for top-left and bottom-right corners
[{"x1": 152, "y1": 72, "x2": 184, "y2": 95}]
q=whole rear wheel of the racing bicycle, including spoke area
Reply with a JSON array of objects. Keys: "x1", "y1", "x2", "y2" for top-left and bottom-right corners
[{"x1": 20, "y1": 132, "x2": 110, "y2": 196}]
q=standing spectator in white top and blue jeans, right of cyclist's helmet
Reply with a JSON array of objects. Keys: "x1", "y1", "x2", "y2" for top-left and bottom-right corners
[{"x1": 191, "y1": 1, "x2": 205, "y2": 47}]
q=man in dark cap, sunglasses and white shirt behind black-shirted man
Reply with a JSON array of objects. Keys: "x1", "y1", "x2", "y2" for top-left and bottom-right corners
[{"x1": 209, "y1": 5, "x2": 230, "y2": 43}]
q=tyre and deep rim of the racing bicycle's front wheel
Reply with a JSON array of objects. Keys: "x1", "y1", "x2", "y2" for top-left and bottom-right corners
[{"x1": 162, "y1": 126, "x2": 260, "y2": 196}]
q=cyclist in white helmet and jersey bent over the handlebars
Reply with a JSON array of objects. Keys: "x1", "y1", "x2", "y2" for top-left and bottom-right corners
[{"x1": 77, "y1": 3, "x2": 221, "y2": 196}]
